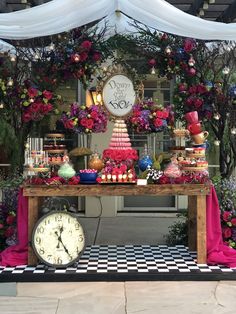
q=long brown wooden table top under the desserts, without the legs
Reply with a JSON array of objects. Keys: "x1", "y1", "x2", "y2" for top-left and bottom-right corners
[{"x1": 23, "y1": 183, "x2": 210, "y2": 197}]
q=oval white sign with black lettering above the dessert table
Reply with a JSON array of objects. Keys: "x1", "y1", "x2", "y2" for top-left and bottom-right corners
[{"x1": 102, "y1": 74, "x2": 136, "y2": 117}]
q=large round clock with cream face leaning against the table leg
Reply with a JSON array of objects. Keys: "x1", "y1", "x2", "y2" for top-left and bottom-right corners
[{"x1": 32, "y1": 211, "x2": 85, "y2": 267}]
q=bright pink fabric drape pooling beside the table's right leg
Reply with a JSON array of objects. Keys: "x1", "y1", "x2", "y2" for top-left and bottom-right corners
[{"x1": 206, "y1": 186, "x2": 236, "y2": 268}]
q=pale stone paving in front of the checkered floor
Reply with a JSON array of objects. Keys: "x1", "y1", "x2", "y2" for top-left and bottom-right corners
[{"x1": 0, "y1": 281, "x2": 236, "y2": 314}]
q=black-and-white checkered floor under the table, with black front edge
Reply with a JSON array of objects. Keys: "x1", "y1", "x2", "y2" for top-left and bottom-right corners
[{"x1": 0, "y1": 245, "x2": 236, "y2": 281}]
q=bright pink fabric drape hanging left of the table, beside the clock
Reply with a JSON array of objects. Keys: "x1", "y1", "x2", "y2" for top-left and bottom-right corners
[{"x1": 0, "y1": 189, "x2": 28, "y2": 266}]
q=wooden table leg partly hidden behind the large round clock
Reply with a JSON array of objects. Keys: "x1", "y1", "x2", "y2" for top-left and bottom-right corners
[{"x1": 28, "y1": 196, "x2": 39, "y2": 265}]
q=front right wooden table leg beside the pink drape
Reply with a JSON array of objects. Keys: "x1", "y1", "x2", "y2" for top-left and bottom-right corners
[{"x1": 196, "y1": 195, "x2": 207, "y2": 264}]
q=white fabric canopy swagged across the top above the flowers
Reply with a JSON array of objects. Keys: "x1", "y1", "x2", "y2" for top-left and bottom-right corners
[{"x1": 0, "y1": 0, "x2": 236, "y2": 40}]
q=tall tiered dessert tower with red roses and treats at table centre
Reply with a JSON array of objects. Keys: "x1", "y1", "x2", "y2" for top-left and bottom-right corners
[{"x1": 102, "y1": 119, "x2": 138, "y2": 183}]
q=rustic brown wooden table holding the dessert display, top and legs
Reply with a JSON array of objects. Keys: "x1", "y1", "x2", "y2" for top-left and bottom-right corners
[{"x1": 23, "y1": 184, "x2": 210, "y2": 265}]
